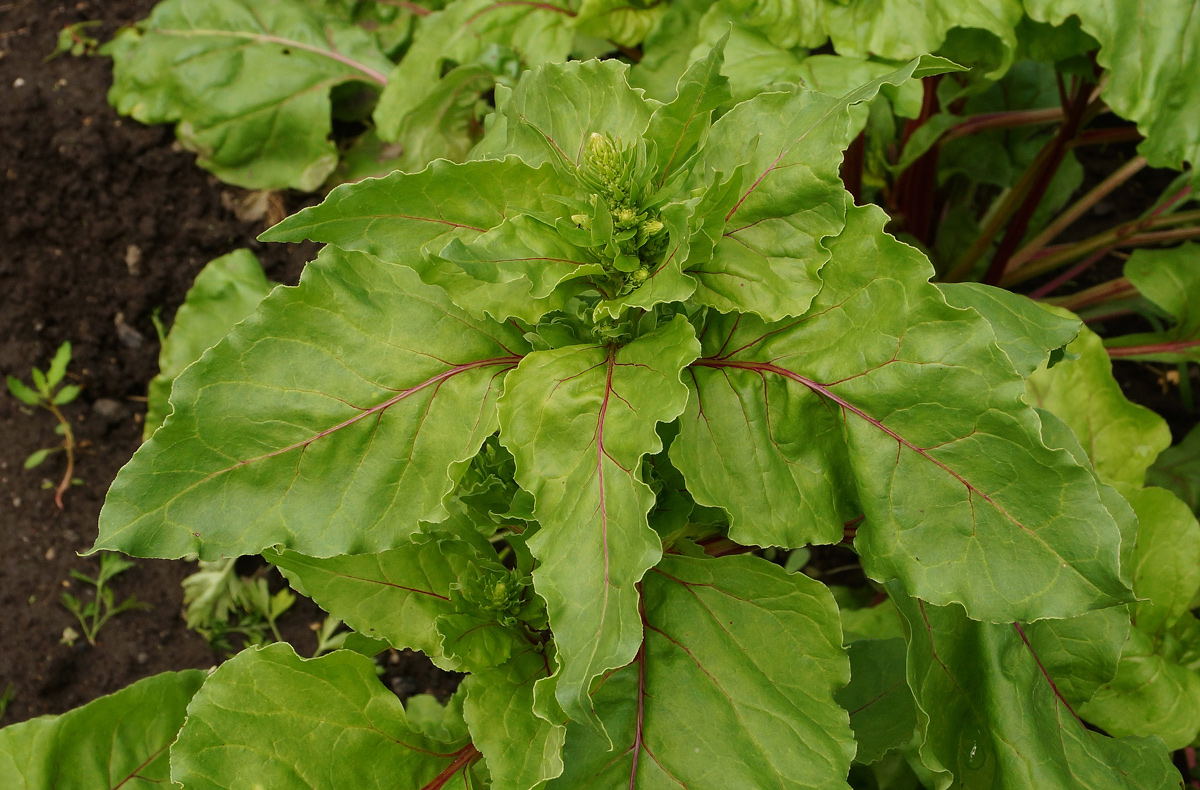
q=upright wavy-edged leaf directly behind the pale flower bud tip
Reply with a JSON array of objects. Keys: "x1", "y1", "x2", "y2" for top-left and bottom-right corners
[{"x1": 472, "y1": 60, "x2": 653, "y2": 172}]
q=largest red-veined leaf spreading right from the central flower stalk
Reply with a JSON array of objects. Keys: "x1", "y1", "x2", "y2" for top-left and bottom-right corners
[{"x1": 671, "y1": 207, "x2": 1130, "y2": 622}]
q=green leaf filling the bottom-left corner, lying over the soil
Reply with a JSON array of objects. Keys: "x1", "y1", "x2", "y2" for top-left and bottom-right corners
[{"x1": 0, "y1": 669, "x2": 205, "y2": 790}]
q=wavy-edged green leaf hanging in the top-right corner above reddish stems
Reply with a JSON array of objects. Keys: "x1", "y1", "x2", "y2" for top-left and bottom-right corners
[{"x1": 1025, "y1": 0, "x2": 1200, "y2": 178}]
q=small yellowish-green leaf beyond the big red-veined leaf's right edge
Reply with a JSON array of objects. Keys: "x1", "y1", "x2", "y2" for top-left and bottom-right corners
[{"x1": 1026, "y1": 327, "x2": 1171, "y2": 485}]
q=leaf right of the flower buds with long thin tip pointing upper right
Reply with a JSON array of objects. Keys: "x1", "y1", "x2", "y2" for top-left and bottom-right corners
[{"x1": 685, "y1": 58, "x2": 954, "y2": 321}]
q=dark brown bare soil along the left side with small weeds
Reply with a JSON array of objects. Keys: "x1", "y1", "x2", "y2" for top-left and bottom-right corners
[{"x1": 0, "y1": 0, "x2": 454, "y2": 724}]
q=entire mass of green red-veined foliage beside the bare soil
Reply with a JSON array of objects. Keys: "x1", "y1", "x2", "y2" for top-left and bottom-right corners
[{"x1": 7, "y1": 0, "x2": 1200, "y2": 790}]
